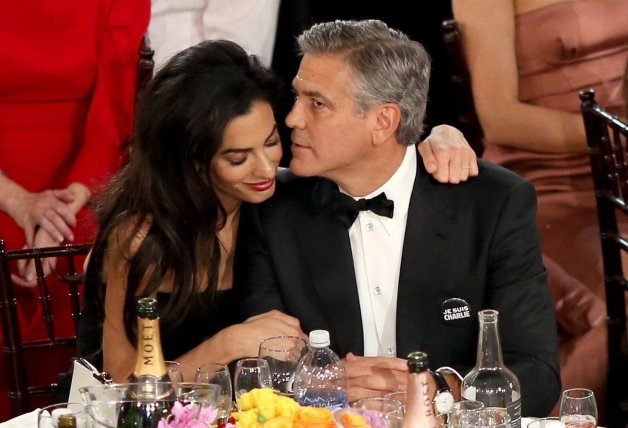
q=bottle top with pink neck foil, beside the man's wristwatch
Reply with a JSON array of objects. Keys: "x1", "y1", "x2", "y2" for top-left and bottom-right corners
[{"x1": 402, "y1": 351, "x2": 439, "y2": 428}]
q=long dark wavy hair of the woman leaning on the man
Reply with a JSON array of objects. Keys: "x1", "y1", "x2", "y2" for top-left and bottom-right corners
[{"x1": 86, "y1": 40, "x2": 281, "y2": 343}]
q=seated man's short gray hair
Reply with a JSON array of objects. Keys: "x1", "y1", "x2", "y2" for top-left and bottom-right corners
[{"x1": 297, "y1": 19, "x2": 430, "y2": 145}]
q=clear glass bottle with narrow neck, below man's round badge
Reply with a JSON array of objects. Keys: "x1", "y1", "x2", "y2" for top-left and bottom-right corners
[{"x1": 462, "y1": 309, "x2": 521, "y2": 428}]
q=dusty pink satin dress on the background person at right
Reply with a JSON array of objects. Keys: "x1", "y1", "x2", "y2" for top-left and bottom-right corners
[{"x1": 483, "y1": 0, "x2": 628, "y2": 414}]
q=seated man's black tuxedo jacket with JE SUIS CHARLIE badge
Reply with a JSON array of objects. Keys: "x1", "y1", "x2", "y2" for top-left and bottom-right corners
[{"x1": 235, "y1": 155, "x2": 561, "y2": 416}]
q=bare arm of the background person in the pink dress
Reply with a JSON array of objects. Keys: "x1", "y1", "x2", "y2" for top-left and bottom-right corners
[{"x1": 452, "y1": 0, "x2": 586, "y2": 153}]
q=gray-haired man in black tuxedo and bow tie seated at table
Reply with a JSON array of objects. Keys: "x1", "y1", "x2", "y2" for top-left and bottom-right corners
[{"x1": 235, "y1": 20, "x2": 560, "y2": 416}]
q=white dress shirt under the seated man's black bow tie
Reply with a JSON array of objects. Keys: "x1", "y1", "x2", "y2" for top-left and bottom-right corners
[{"x1": 340, "y1": 145, "x2": 417, "y2": 357}]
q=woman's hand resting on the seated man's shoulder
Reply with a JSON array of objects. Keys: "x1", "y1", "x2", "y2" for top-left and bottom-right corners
[{"x1": 418, "y1": 125, "x2": 479, "y2": 184}]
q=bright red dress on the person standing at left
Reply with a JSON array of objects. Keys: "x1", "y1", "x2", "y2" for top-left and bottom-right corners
[{"x1": 0, "y1": 0, "x2": 150, "y2": 421}]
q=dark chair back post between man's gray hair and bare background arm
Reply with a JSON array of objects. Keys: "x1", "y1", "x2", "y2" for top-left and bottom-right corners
[{"x1": 441, "y1": 19, "x2": 484, "y2": 157}]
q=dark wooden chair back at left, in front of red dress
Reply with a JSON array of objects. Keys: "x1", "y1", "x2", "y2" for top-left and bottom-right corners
[{"x1": 0, "y1": 240, "x2": 91, "y2": 416}]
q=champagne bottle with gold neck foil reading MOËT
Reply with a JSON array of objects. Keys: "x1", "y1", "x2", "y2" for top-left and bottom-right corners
[{"x1": 118, "y1": 297, "x2": 174, "y2": 428}]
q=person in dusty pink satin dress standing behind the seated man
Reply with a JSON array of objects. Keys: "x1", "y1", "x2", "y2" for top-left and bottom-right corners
[{"x1": 453, "y1": 0, "x2": 628, "y2": 423}]
